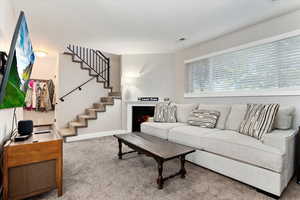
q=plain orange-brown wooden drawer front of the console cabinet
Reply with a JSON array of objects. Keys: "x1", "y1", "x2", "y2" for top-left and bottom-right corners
[{"x1": 5, "y1": 140, "x2": 62, "y2": 167}]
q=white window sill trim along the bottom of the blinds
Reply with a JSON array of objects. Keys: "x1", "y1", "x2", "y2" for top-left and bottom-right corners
[{"x1": 184, "y1": 88, "x2": 300, "y2": 98}]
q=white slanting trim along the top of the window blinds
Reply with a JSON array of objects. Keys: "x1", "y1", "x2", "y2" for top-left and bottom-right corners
[{"x1": 184, "y1": 30, "x2": 300, "y2": 64}]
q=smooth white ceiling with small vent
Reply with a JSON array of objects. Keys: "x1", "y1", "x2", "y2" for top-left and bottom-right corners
[{"x1": 13, "y1": 0, "x2": 300, "y2": 54}]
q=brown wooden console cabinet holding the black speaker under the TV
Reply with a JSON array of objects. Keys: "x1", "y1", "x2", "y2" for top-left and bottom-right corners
[{"x1": 2, "y1": 131, "x2": 63, "y2": 200}]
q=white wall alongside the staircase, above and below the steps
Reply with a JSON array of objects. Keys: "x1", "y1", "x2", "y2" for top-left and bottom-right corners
[{"x1": 55, "y1": 54, "x2": 121, "y2": 135}]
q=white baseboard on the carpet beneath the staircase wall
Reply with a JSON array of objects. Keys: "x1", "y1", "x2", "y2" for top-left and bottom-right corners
[{"x1": 65, "y1": 130, "x2": 128, "y2": 142}]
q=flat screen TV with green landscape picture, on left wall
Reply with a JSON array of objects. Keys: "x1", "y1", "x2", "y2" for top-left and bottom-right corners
[{"x1": 0, "y1": 12, "x2": 35, "y2": 109}]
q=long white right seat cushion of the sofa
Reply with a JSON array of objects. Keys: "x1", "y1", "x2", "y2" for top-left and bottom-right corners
[{"x1": 169, "y1": 126, "x2": 285, "y2": 173}]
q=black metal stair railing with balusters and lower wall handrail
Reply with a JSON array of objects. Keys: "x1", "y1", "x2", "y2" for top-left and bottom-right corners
[{"x1": 59, "y1": 44, "x2": 110, "y2": 101}]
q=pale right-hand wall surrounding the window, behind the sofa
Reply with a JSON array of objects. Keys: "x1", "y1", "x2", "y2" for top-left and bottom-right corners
[{"x1": 175, "y1": 10, "x2": 300, "y2": 126}]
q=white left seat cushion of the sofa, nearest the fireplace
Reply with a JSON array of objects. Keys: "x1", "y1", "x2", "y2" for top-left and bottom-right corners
[{"x1": 141, "y1": 122, "x2": 186, "y2": 139}]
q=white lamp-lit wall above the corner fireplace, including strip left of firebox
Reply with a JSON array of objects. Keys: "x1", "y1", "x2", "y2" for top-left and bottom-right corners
[{"x1": 121, "y1": 54, "x2": 175, "y2": 129}]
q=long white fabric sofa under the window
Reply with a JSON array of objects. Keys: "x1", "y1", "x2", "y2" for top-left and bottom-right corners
[{"x1": 141, "y1": 104, "x2": 297, "y2": 196}]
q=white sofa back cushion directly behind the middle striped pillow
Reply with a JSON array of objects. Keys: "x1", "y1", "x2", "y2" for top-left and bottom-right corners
[{"x1": 198, "y1": 104, "x2": 231, "y2": 129}]
